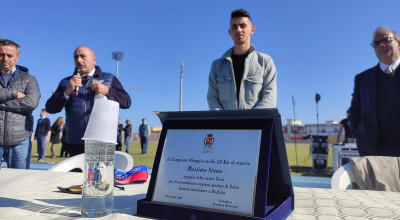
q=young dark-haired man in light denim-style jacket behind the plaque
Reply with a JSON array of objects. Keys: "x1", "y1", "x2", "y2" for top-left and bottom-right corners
[{"x1": 207, "y1": 9, "x2": 276, "y2": 110}]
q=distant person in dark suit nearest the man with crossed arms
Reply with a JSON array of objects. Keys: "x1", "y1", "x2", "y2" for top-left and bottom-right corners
[{"x1": 35, "y1": 109, "x2": 51, "y2": 162}]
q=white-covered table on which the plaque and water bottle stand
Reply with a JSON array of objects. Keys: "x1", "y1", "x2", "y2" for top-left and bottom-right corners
[{"x1": 0, "y1": 168, "x2": 400, "y2": 220}]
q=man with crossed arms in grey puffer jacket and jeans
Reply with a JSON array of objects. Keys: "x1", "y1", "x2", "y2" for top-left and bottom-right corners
[{"x1": 0, "y1": 39, "x2": 40, "y2": 169}]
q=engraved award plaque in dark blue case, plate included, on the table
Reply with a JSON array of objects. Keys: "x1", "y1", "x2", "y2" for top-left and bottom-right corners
[{"x1": 137, "y1": 109, "x2": 294, "y2": 220}]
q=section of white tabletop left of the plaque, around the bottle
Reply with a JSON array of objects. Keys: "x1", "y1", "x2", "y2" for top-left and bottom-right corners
[{"x1": 0, "y1": 168, "x2": 148, "y2": 220}]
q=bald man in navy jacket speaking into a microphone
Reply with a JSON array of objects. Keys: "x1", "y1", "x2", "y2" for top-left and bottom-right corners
[{"x1": 46, "y1": 46, "x2": 131, "y2": 157}]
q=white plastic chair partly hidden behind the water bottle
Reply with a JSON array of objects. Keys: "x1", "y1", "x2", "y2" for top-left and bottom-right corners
[{"x1": 48, "y1": 151, "x2": 134, "y2": 172}]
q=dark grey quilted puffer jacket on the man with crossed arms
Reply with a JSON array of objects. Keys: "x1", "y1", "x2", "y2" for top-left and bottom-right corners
[{"x1": 0, "y1": 65, "x2": 40, "y2": 147}]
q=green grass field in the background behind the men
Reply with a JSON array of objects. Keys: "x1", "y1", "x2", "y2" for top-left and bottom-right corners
[{"x1": 31, "y1": 141, "x2": 332, "y2": 176}]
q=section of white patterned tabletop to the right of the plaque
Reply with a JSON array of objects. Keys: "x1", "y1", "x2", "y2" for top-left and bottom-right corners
[{"x1": 288, "y1": 187, "x2": 400, "y2": 220}]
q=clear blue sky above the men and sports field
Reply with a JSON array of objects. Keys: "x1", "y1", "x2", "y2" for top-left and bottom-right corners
[{"x1": 0, "y1": 0, "x2": 400, "y2": 130}]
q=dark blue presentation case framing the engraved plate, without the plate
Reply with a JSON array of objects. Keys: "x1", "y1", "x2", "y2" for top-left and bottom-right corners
[{"x1": 137, "y1": 109, "x2": 294, "y2": 220}]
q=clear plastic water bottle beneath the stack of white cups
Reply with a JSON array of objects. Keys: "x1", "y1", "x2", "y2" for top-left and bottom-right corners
[{"x1": 81, "y1": 140, "x2": 115, "y2": 218}]
